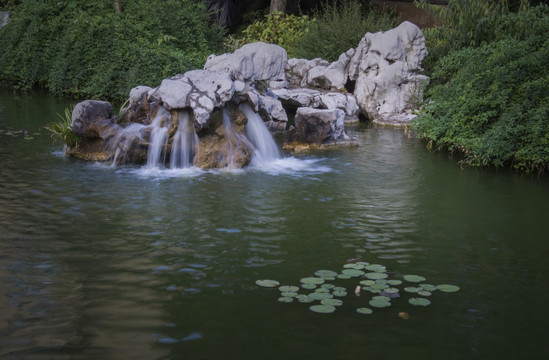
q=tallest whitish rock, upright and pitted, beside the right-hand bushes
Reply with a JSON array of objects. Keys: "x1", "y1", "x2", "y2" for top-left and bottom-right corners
[{"x1": 349, "y1": 21, "x2": 429, "y2": 124}]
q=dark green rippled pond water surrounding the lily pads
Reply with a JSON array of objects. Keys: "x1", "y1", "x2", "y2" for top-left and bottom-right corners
[{"x1": 0, "y1": 91, "x2": 549, "y2": 359}]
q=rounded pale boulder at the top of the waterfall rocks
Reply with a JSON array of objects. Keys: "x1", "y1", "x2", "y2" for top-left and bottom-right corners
[{"x1": 204, "y1": 42, "x2": 288, "y2": 82}]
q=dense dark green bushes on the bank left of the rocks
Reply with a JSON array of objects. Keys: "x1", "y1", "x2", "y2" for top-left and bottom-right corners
[{"x1": 0, "y1": 0, "x2": 223, "y2": 99}]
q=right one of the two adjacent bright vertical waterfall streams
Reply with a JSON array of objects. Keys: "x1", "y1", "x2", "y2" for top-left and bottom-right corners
[{"x1": 170, "y1": 111, "x2": 199, "y2": 169}]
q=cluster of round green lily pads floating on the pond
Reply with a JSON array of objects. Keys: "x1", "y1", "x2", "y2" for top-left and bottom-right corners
[{"x1": 255, "y1": 261, "x2": 460, "y2": 318}]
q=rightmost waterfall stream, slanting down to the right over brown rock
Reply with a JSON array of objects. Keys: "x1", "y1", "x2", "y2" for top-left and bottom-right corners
[{"x1": 239, "y1": 103, "x2": 281, "y2": 165}]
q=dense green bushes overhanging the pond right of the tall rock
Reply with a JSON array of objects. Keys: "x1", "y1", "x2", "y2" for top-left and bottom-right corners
[{"x1": 415, "y1": 5, "x2": 549, "y2": 172}]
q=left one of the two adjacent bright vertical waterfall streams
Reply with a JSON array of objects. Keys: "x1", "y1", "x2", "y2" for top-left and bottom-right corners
[{"x1": 147, "y1": 107, "x2": 171, "y2": 168}]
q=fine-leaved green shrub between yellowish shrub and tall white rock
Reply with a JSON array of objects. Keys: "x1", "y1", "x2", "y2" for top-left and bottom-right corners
[{"x1": 295, "y1": 0, "x2": 398, "y2": 61}]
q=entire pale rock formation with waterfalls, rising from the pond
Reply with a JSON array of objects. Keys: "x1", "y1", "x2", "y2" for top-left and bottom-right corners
[{"x1": 68, "y1": 22, "x2": 428, "y2": 168}]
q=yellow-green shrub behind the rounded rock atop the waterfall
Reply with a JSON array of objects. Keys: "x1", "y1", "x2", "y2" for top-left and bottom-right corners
[{"x1": 226, "y1": 12, "x2": 311, "y2": 56}]
